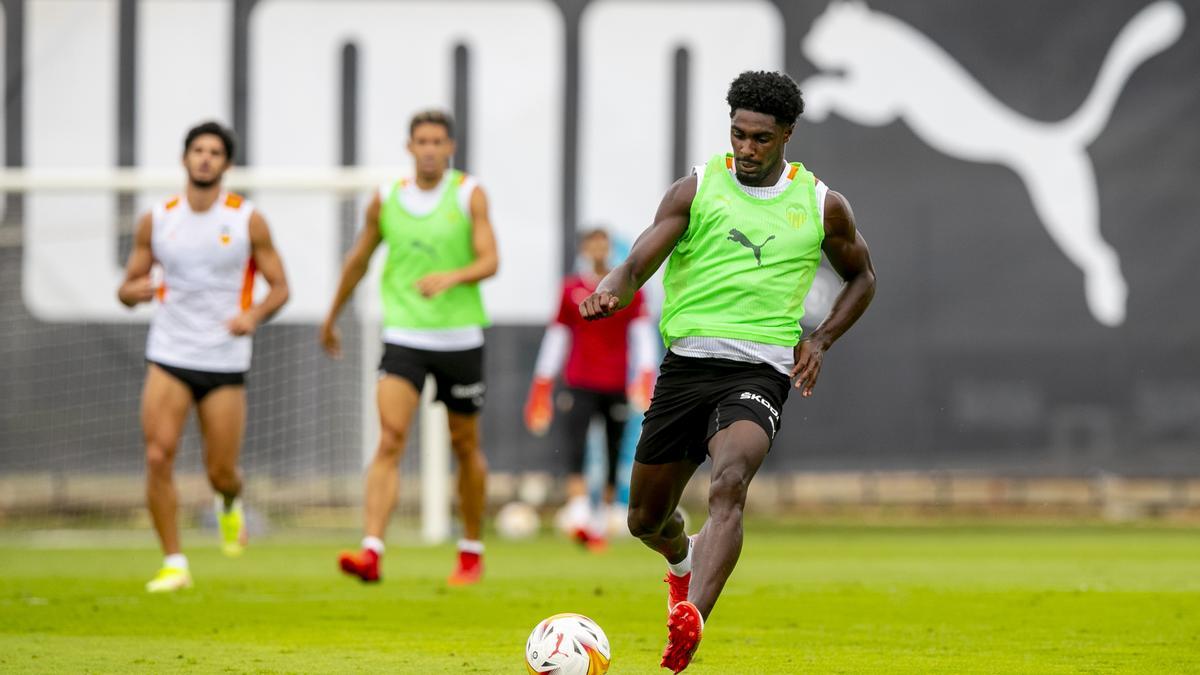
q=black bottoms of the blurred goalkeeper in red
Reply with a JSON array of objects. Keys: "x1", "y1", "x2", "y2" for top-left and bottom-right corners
[{"x1": 556, "y1": 387, "x2": 629, "y2": 485}]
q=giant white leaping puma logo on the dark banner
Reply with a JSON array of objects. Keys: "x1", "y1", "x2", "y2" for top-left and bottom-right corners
[{"x1": 800, "y1": 0, "x2": 1184, "y2": 325}]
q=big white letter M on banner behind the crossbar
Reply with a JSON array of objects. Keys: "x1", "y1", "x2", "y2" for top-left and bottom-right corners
[{"x1": 248, "y1": 0, "x2": 563, "y2": 322}]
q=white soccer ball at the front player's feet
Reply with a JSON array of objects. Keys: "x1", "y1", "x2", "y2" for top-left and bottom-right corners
[{"x1": 526, "y1": 614, "x2": 612, "y2": 675}]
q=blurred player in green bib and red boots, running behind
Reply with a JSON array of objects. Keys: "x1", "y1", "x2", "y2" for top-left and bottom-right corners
[{"x1": 320, "y1": 110, "x2": 499, "y2": 585}]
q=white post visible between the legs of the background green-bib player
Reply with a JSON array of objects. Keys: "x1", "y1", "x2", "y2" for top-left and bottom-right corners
[{"x1": 421, "y1": 376, "x2": 450, "y2": 544}]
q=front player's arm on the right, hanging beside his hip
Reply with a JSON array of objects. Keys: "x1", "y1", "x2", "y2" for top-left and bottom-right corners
[{"x1": 792, "y1": 190, "x2": 875, "y2": 396}]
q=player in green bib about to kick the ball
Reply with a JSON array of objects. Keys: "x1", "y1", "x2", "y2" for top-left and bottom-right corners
[{"x1": 580, "y1": 71, "x2": 875, "y2": 673}]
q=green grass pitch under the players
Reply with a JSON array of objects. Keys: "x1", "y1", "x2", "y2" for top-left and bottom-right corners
[{"x1": 0, "y1": 522, "x2": 1200, "y2": 674}]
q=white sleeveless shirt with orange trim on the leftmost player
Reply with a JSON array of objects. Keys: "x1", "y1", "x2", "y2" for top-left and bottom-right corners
[{"x1": 146, "y1": 193, "x2": 254, "y2": 372}]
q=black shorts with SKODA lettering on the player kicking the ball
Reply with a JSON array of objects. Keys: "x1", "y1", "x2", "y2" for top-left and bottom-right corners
[{"x1": 634, "y1": 351, "x2": 791, "y2": 464}]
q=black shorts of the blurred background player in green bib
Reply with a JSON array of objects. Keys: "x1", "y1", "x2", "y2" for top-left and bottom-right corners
[{"x1": 379, "y1": 344, "x2": 487, "y2": 414}]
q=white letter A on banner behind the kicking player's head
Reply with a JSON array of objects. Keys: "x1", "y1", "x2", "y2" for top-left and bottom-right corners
[{"x1": 580, "y1": 0, "x2": 784, "y2": 297}]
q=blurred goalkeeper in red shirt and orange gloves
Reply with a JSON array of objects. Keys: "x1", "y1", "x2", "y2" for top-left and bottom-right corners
[{"x1": 524, "y1": 229, "x2": 658, "y2": 550}]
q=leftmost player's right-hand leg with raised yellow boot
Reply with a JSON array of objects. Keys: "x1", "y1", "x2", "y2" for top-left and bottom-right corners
[{"x1": 196, "y1": 383, "x2": 246, "y2": 556}]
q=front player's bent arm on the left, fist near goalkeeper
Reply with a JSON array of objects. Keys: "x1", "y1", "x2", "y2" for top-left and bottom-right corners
[{"x1": 580, "y1": 174, "x2": 698, "y2": 321}]
